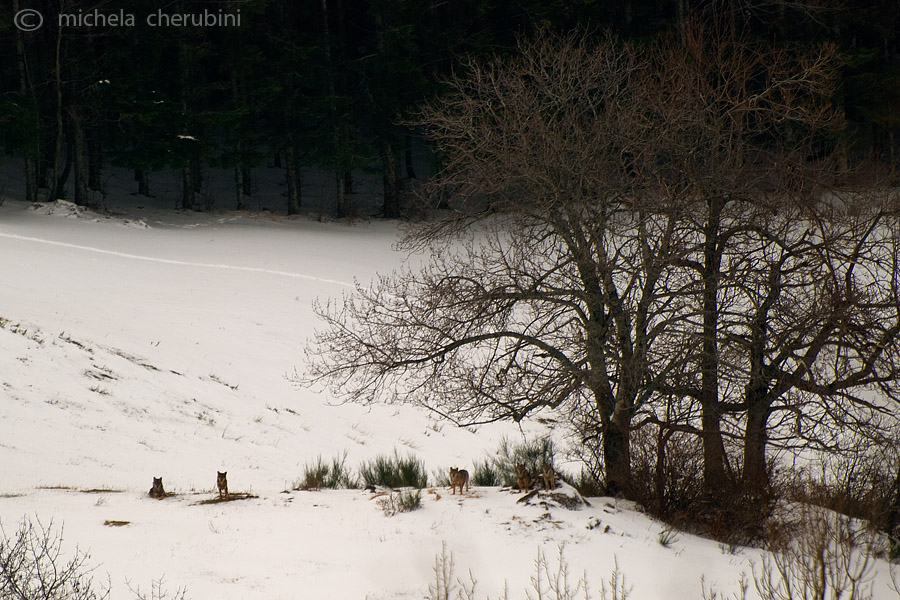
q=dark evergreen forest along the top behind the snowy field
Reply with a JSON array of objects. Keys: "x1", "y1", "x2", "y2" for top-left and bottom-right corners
[{"x1": 0, "y1": 0, "x2": 900, "y2": 217}]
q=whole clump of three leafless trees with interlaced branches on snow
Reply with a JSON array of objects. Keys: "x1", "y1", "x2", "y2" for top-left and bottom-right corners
[{"x1": 307, "y1": 21, "x2": 900, "y2": 502}]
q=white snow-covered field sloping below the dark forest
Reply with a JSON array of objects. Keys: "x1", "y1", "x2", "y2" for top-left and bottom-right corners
[{"x1": 0, "y1": 171, "x2": 897, "y2": 600}]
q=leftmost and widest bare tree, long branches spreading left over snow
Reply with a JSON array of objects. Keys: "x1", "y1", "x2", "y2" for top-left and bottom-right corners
[{"x1": 307, "y1": 30, "x2": 677, "y2": 491}]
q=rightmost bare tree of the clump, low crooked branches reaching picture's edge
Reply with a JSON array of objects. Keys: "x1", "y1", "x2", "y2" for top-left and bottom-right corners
[{"x1": 723, "y1": 200, "x2": 900, "y2": 489}]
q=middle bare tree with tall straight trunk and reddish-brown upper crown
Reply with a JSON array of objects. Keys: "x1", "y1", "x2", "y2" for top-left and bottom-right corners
[{"x1": 638, "y1": 13, "x2": 856, "y2": 493}]
